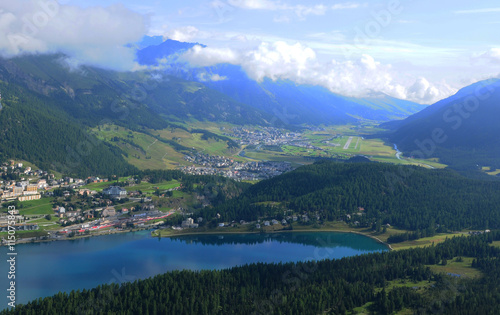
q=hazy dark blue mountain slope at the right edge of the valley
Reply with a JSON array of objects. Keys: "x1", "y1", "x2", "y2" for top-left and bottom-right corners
[{"x1": 381, "y1": 79, "x2": 500, "y2": 170}]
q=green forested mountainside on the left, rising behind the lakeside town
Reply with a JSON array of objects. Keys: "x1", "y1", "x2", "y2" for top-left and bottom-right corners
[{"x1": 0, "y1": 55, "x2": 274, "y2": 176}]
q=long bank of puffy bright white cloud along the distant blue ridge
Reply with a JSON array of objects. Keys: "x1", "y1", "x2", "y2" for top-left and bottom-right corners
[{"x1": 182, "y1": 41, "x2": 456, "y2": 104}]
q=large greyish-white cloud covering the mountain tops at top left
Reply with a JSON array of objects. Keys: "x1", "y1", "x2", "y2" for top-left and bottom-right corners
[{"x1": 0, "y1": 0, "x2": 148, "y2": 70}]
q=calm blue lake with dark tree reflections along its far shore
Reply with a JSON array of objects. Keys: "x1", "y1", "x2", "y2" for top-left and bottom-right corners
[{"x1": 0, "y1": 231, "x2": 387, "y2": 309}]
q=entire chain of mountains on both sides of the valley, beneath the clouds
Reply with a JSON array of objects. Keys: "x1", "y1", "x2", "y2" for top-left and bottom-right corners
[{"x1": 0, "y1": 37, "x2": 500, "y2": 175}]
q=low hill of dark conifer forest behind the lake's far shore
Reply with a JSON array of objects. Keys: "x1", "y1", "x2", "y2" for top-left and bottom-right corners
[{"x1": 203, "y1": 161, "x2": 500, "y2": 233}]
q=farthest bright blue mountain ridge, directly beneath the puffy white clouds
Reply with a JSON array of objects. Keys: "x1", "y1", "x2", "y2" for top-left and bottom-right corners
[{"x1": 137, "y1": 40, "x2": 425, "y2": 125}]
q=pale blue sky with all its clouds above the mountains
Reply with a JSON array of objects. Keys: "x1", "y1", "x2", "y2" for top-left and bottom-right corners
[{"x1": 0, "y1": 0, "x2": 500, "y2": 103}]
